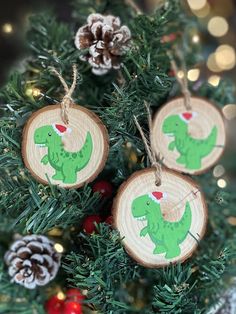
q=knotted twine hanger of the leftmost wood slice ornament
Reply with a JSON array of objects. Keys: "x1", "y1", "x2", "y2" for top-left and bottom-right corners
[{"x1": 50, "y1": 64, "x2": 78, "y2": 125}]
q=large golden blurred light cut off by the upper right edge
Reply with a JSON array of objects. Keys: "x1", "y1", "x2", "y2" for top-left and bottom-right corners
[{"x1": 215, "y1": 45, "x2": 236, "y2": 70}]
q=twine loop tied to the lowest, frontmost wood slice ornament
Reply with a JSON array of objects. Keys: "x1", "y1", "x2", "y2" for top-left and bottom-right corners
[{"x1": 134, "y1": 102, "x2": 161, "y2": 186}]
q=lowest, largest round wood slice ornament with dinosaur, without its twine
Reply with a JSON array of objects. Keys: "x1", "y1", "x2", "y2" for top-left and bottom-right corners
[{"x1": 113, "y1": 168, "x2": 207, "y2": 268}]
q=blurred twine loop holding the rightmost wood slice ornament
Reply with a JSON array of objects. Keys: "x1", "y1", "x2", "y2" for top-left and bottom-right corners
[{"x1": 167, "y1": 49, "x2": 192, "y2": 111}]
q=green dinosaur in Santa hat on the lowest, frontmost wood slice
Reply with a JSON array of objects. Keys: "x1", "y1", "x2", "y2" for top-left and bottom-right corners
[{"x1": 132, "y1": 192, "x2": 192, "y2": 259}]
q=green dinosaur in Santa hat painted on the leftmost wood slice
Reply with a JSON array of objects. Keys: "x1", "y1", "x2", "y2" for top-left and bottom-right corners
[{"x1": 34, "y1": 124, "x2": 93, "y2": 184}]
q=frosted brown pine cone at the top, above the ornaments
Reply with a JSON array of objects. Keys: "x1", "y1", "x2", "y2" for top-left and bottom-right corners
[{"x1": 75, "y1": 13, "x2": 131, "y2": 75}]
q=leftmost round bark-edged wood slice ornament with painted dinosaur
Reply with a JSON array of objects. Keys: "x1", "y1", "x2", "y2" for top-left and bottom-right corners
[{"x1": 22, "y1": 104, "x2": 109, "y2": 188}]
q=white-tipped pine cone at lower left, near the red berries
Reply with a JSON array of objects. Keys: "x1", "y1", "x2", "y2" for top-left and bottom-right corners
[{"x1": 5, "y1": 235, "x2": 61, "y2": 289}]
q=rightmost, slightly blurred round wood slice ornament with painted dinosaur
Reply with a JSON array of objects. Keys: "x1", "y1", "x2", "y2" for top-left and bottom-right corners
[{"x1": 153, "y1": 97, "x2": 226, "y2": 175}]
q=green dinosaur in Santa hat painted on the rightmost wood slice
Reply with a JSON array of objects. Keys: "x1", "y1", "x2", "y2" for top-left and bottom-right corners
[{"x1": 162, "y1": 112, "x2": 217, "y2": 170}]
